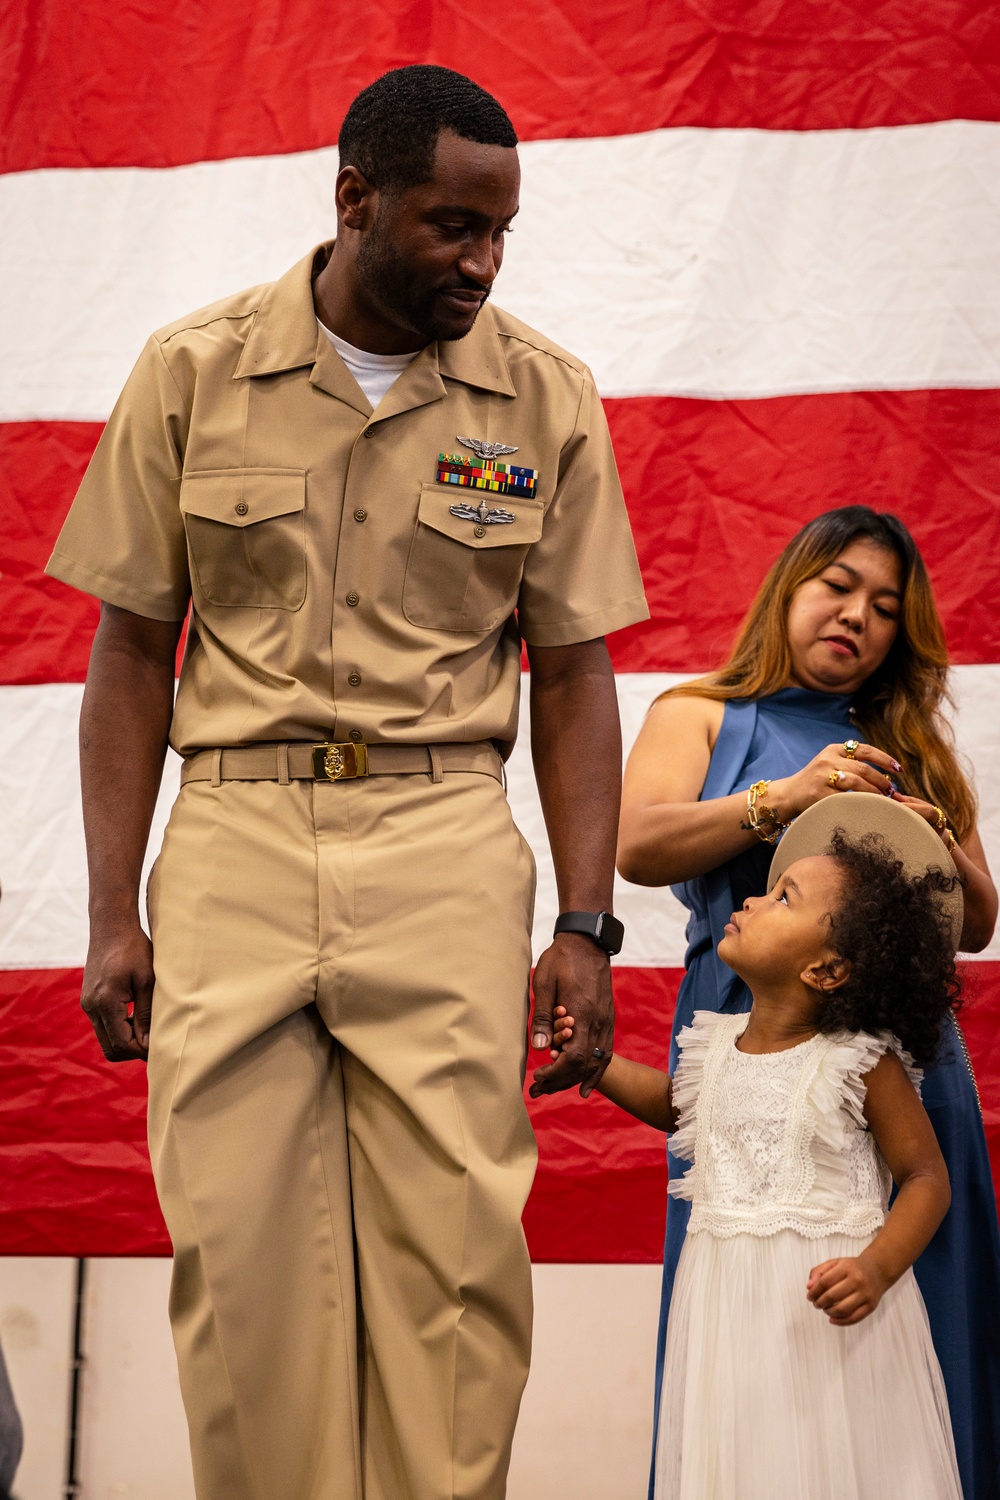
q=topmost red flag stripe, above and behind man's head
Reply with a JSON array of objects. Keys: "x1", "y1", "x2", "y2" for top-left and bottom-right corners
[{"x1": 0, "y1": 0, "x2": 1000, "y2": 171}]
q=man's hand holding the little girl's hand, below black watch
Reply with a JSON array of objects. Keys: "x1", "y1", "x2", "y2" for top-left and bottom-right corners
[{"x1": 529, "y1": 933, "x2": 615, "y2": 1100}]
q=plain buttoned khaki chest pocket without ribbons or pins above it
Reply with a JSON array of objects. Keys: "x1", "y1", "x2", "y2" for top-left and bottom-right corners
[{"x1": 180, "y1": 470, "x2": 306, "y2": 609}]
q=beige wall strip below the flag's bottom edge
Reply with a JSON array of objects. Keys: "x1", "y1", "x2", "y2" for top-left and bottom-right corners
[{"x1": 0, "y1": 1259, "x2": 660, "y2": 1500}]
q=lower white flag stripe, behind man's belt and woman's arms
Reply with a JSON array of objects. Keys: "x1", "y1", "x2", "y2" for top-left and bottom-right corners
[{"x1": 0, "y1": 666, "x2": 1000, "y2": 969}]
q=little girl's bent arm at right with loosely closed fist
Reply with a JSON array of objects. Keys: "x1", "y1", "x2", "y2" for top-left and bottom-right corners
[{"x1": 807, "y1": 1052, "x2": 952, "y2": 1326}]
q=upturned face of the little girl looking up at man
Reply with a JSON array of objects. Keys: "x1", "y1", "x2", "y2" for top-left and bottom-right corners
[{"x1": 718, "y1": 855, "x2": 843, "y2": 990}]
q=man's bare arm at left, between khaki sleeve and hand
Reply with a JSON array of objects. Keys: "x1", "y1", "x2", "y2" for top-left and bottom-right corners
[{"x1": 79, "y1": 605, "x2": 180, "y2": 929}]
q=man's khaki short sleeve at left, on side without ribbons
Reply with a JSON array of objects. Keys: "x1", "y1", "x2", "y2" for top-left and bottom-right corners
[{"x1": 45, "y1": 339, "x2": 190, "y2": 620}]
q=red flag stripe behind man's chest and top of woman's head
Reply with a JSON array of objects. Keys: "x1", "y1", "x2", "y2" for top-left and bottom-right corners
[{"x1": 7, "y1": 390, "x2": 1000, "y2": 684}]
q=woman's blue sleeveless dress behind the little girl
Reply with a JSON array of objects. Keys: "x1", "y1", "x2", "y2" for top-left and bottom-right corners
[{"x1": 649, "y1": 687, "x2": 1000, "y2": 1500}]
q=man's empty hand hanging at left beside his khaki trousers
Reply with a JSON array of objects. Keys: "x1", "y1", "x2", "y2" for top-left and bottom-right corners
[{"x1": 79, "y1": 920, "x2": 153, "y2": 1062}]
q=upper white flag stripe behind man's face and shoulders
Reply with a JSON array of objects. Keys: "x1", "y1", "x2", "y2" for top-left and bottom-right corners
[{"x1": 0, "y1": 120, "x2": 1000, "y2": 420}]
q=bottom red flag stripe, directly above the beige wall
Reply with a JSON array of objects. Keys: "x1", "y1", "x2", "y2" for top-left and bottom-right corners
[{"x1": 0, "y1": 963, "x2": 1000, "y2": 1263}]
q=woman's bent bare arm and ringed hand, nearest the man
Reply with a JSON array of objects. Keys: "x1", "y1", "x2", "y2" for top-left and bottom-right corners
[{"x1": 618, "y1": 698, "x2": 898, "y2": 885}]
